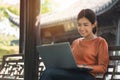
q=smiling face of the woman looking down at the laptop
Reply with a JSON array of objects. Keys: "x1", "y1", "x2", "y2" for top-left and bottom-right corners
[{"x1": 78, "y1": 17, "x2": 95, "y2": 38}]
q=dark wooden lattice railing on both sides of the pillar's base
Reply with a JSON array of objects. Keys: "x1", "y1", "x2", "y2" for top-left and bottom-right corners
[{"x1": 0, "y1": 54, "x2": 45, "y2": 80}]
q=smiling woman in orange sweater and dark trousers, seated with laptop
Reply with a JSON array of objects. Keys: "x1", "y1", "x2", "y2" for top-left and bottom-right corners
[{"x1": 40, "y1": 9, "x2": 109, "y2": 80}]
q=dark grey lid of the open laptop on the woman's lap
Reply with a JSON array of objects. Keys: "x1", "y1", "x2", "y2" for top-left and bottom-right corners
[{"x1": 37, "y1": 42, "x2": 93, "y2": 70}]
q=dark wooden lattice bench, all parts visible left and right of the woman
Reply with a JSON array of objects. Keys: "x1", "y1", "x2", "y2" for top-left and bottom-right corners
[{"x1": 0, "y1": 46, "x2": 120, "y2": 80}]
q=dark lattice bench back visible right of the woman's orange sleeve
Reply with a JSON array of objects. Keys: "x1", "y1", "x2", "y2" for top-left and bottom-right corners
[{"x1": 96, "y1": 46, "x2": 120, "y2": 80}]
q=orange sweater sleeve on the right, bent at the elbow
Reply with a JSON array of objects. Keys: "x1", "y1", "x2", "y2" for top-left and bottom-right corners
[{"x1": 92, "y1": 39, "x2": 109, "y2": 74}]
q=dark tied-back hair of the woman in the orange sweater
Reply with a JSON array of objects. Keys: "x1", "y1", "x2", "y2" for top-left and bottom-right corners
[{"x1": 77, "y1": 9, "x2": 97, "y2": 34}]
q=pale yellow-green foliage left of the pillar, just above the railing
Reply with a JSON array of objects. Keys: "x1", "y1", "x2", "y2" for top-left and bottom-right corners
[{"x1": 0, "y1": 34, "x2": 18, "y2": 58}]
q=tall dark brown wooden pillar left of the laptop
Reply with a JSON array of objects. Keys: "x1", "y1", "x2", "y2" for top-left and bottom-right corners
[{"x1": 20, "y1": 0, "x2": 40, "y2": 80}]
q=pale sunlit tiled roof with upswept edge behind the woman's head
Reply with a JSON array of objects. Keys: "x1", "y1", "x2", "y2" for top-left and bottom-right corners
[{"x1": 40, "y1": 0, "x2": 119, "y2": 25}]
